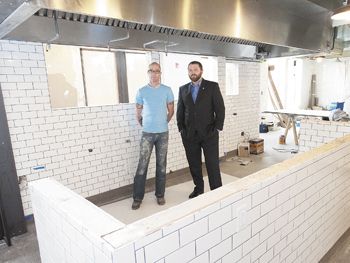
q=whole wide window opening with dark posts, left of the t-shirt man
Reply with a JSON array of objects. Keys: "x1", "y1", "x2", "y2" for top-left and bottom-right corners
[{"x1": 45, "y1": 45, "x2": 150, "y2": 108}]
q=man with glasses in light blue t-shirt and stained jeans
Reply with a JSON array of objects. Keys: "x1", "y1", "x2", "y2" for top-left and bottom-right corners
[{"x1": 132, "y1": 62, "x2": 174, "y2": 210}]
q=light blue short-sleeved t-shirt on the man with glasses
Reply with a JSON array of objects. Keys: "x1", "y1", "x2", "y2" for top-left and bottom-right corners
[{"x1": 136, "y1": 84, "x2": 174, "y2": 133}]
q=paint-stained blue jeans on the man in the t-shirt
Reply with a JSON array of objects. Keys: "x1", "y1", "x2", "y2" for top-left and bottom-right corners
[{"x1": 133, "y1": 132, "x2": 169, "y2": 201}]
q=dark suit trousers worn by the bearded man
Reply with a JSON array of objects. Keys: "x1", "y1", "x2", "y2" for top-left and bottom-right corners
[{"x1": 181, "y1": 131, "x2": 222, "y2": 192}]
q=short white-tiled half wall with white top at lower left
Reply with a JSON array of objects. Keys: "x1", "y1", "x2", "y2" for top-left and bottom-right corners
[{"x1": 29, "y1": 178, "x2": 124, "y2": 262}]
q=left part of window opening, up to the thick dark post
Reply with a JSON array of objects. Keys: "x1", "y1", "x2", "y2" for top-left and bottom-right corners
[{"x1": 45, "y1": 45, "x2": 120, "y2": 109}]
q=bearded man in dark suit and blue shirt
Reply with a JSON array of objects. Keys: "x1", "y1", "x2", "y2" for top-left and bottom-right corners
[{"x1": 176, "y1": 61, "x2": 225, "y2": 198}]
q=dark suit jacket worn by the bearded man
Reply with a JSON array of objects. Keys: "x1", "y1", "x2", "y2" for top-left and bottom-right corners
[{"x1": 176, "y1": 79, "x2": 225, "y2": 138}]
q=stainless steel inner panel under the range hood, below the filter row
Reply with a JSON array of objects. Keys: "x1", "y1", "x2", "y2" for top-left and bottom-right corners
[{"x1": 6, "y1": 14, "x2": 263, "y2": 60}]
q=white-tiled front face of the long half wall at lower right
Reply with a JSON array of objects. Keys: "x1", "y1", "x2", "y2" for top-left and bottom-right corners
[{"x1": 118, "y1": 137, "x2": 350, "y2": 263}]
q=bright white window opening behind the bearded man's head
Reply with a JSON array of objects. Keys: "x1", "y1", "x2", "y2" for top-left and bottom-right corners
[{"x1": 160, "y1": 53, "x2": 218, "y2": 99}]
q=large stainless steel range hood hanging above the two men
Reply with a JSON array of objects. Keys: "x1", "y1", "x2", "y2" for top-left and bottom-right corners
[{"x1": 0, "y1": 0, "x2": 335, "y2": 59}]
